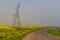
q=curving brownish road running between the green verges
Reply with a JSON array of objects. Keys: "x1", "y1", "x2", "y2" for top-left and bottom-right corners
[{"x1": 23, "y1": 29, "x2": 60, "y2": 40}]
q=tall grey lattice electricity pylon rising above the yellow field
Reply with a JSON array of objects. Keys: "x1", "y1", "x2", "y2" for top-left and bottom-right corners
[{"x1": 13, "y1": 3, "x2": 20, "y2": 26}]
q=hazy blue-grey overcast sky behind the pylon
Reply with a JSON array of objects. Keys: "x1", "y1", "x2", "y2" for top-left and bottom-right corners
[{"x1": 0, "y1": 0, "x2": 60, "y2": 26}]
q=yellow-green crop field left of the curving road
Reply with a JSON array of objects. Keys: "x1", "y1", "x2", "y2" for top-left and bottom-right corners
[{"x1": 0, "y1": 26, "x2": 42, "y2": 40}]
